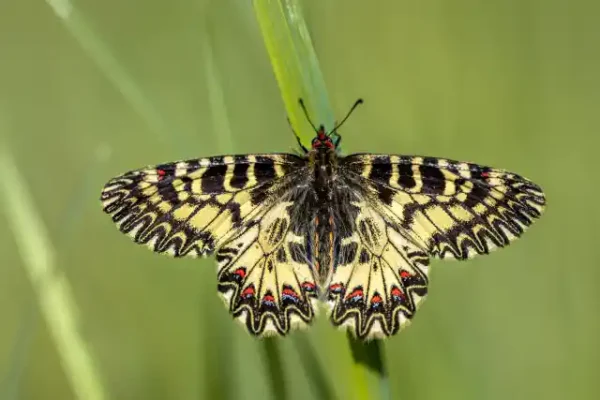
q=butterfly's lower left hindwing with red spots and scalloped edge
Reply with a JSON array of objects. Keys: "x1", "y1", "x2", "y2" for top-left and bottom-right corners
[{"x1": 217, "y1": 198, "x2": 318, "y2": 336}]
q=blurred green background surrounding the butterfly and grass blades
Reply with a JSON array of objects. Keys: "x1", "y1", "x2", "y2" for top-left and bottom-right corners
[{"x1": 0, "y1": 0, "x2": 600, "y2": 400}]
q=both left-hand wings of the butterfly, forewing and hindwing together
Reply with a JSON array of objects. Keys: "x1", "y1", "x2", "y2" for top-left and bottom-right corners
[{"x1": 101, "y1": 154, "x2": 317, "y2": 335}]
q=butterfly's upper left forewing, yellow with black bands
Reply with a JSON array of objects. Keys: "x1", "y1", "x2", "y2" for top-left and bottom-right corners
[{"x1": 101, "y1": 154, "x2": 305, "y2": 257}]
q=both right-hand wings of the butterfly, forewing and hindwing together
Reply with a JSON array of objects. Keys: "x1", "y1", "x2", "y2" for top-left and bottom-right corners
[{"x1": 327, "y1": 154, "x2": 545, "y2": 339}]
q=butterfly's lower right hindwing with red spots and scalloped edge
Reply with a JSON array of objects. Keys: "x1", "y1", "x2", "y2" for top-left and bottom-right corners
[{"x1": 327, "y1": 200, "x2": 429, "y2": 340}]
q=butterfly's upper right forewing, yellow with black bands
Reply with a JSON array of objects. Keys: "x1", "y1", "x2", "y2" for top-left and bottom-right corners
[{"x1": 341, "y1": 154, "x2": 545, "y2": 259}]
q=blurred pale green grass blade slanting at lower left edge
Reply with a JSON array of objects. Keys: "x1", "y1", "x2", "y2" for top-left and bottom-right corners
[{"x1": 0, "y1": 143, "x2": 107, "y2": 400}]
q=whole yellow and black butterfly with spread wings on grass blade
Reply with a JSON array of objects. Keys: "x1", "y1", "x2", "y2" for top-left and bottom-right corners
[{"x1": 101, "y1": 100, "x2": 545, "y2": 340}]
